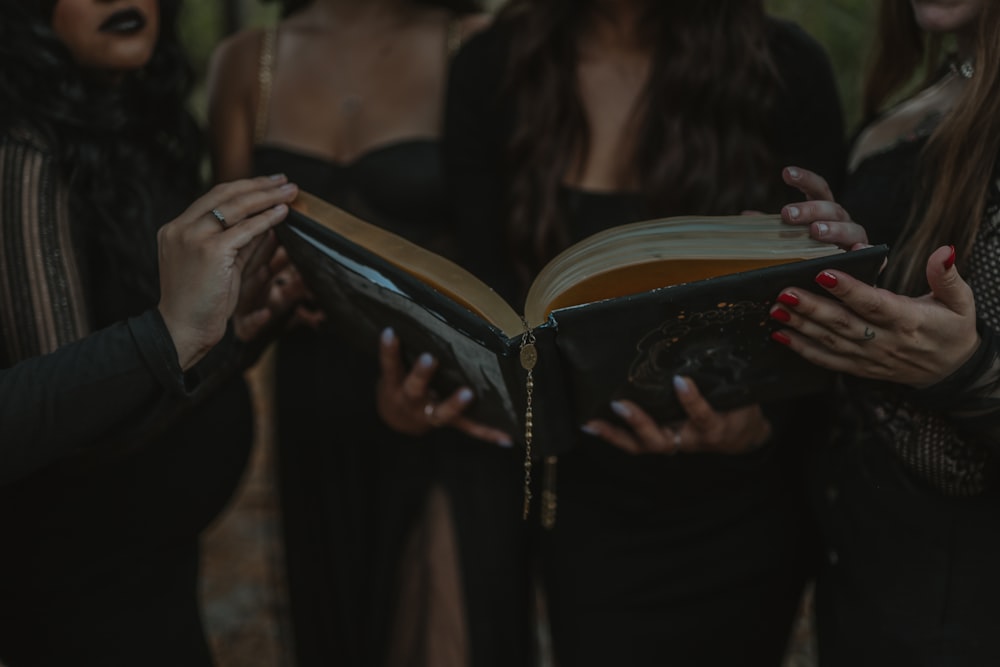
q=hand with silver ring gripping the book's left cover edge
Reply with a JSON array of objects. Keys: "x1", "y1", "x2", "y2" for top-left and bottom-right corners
[{"x1": 157, "y1": 176, "x2": 298, "y2": 370}]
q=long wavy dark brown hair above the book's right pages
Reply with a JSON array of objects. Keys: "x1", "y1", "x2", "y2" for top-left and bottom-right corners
[{"x1": 497, "y1": 0, "x2": 780, "y2": 288}]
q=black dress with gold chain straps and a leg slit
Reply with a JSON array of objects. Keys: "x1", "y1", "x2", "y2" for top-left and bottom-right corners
[{"x1": 254, "y1": 139, "x2": 528, "y2": 667}]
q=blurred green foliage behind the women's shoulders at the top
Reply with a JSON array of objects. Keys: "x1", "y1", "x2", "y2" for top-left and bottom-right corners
[{"x1": 182, "y1": 0, "x2": 877, "y2": 132}]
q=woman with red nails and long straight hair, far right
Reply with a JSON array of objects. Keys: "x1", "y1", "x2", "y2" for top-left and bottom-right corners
[{"x1": 773, "y1": 0, "x2": 1000, "y2": 665}]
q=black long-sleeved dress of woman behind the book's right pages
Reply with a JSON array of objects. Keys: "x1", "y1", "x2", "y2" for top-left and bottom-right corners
[{"x1": 445, "y1": 15, "x2": 844, "y2": 667}]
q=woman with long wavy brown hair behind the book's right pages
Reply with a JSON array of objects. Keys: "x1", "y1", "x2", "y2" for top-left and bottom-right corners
[{"x1": 384, "y1": 0, "x2": 843, "y2": 666}]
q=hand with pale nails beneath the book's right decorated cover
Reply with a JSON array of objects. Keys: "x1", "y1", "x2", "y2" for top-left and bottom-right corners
[{"x1": 583, "y1": 377, "x2": 771, "y2": 454}]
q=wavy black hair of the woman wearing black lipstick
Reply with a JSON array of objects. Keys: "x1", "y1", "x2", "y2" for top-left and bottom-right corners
[{"x1": 0, "y1": 0, "x2": 204, "y2": 298}]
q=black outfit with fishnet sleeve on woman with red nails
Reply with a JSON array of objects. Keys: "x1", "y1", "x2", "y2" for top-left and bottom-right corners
[{"x1": 811, "y1": 118, "x2": 1000, "y2": 667}]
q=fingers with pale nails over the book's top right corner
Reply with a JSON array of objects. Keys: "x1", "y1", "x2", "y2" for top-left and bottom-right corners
[{"x1": 781, "y1": 166, "x2": 868, "y2": 250}]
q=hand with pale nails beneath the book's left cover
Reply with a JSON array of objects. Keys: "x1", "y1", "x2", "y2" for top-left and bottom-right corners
[{"x1": 376, "y1": 329, "x2": 513, "y2": 447}]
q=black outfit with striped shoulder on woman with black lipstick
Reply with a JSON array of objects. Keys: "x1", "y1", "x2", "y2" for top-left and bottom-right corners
[{"x1": 0, "y1": 131, "x2": 252, "y2": 667}]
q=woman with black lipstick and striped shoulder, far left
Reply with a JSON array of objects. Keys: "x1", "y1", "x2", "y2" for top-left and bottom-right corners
[{"x1": 0, "y1": 0, "x2": 297, "y2": 667}]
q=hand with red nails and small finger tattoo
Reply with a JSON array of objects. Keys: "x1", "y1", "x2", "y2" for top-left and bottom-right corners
[{"x1": 771, "y1": 246, "x2": 980, "y2": 387}]
